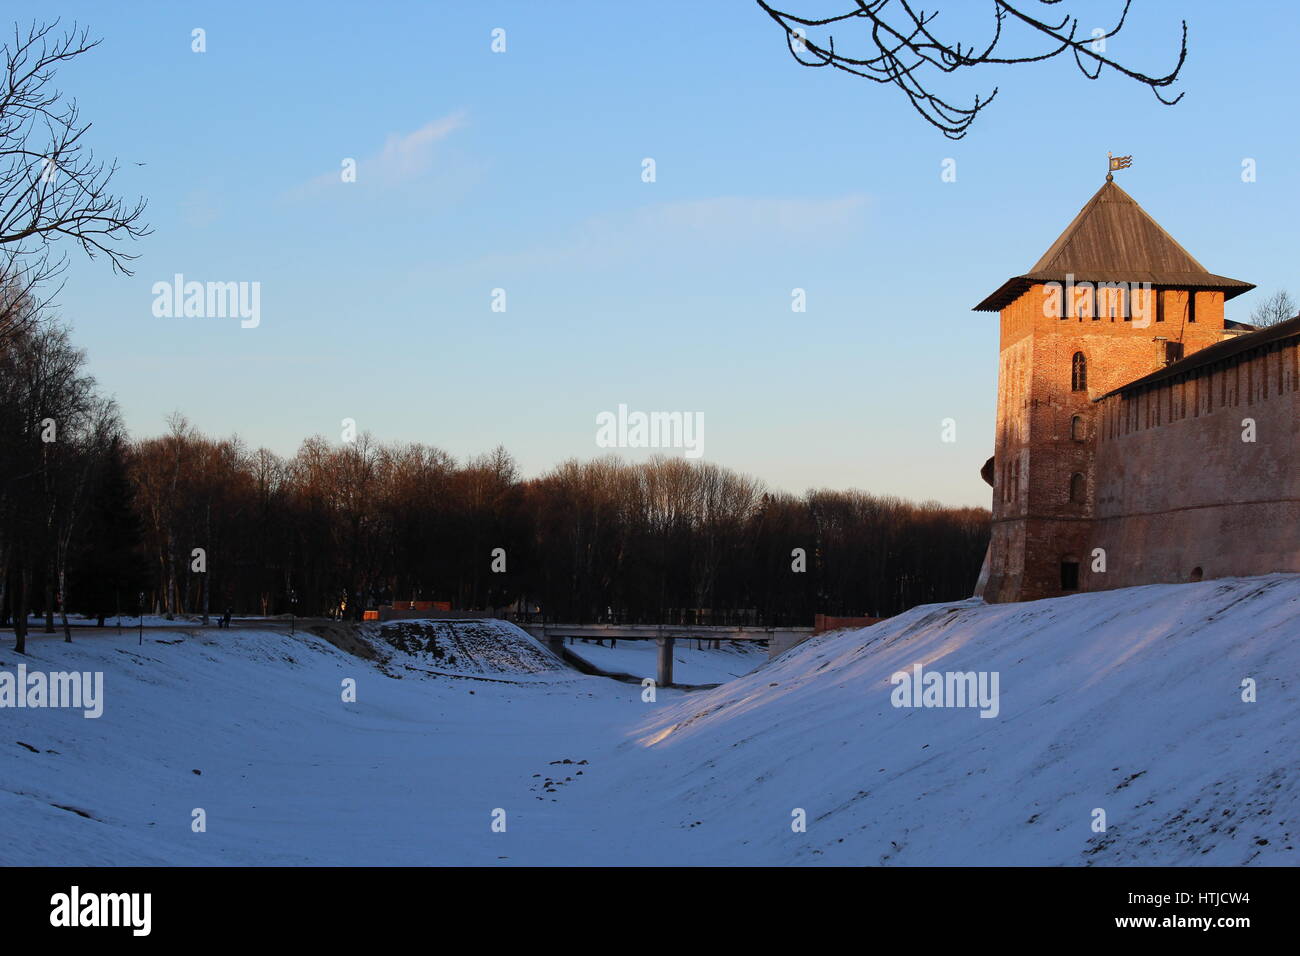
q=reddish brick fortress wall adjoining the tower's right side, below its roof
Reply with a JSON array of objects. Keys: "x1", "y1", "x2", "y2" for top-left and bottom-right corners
[{"x1": 1083, "y1": 338, "x2": 1300, "y2": 589}]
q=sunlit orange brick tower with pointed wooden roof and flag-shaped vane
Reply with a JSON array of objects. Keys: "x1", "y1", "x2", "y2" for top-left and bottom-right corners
[{"x1": 975, "y1": 176, "x2": 1255, "y2": 602}]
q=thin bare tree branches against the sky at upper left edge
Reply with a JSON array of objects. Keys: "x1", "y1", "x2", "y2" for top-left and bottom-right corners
[{"x1": 0, "y1": 20, "x2": 150, "y2": 342}]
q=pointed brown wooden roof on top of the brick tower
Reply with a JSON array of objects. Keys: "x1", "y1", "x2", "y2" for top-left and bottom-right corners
[{"x1": 974, "y1": 179, "x2": 1255, "y2": 312}]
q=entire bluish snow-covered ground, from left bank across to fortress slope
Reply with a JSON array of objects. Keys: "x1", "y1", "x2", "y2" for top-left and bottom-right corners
[{"x1": 0, "y1": 575, "x2": 1300, "y2": 865}]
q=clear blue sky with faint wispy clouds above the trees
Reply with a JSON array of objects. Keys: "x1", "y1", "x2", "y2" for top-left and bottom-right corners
[{"x1": 7, "y1": 0, "x2": 1300, "y2": 505}]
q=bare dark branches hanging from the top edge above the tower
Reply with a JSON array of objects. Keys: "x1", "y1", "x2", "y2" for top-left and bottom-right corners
[{"x1": 757, "y1": 0, "x2": 1187, "y2": 139}]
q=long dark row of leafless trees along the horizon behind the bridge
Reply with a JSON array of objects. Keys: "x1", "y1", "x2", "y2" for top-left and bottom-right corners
[{"x1": 0, "y1": 320, "x2": 989, "y2": 647}]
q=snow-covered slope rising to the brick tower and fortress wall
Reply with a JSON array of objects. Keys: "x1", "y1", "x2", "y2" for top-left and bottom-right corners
[{"x1": 624, "y1": 575, "x2": 1300, "y2": 865}]
